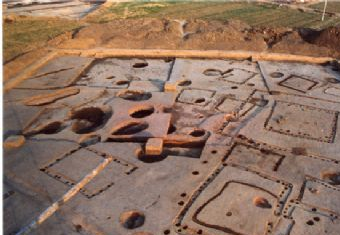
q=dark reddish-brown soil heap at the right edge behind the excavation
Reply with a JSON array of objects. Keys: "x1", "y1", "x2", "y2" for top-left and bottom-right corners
[{"x1": 299, "y1": 27, "x2": 340, "y2": 53}]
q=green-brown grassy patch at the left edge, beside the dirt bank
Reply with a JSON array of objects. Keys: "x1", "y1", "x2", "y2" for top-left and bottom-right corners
[{"x1": 3, "y1": 17, "x2": 81, "y2": 62}]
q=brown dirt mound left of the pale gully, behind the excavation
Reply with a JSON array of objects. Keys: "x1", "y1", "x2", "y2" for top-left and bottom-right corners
[{"x1": 70, "y1": 19, "x2": 180, "y2": 49}]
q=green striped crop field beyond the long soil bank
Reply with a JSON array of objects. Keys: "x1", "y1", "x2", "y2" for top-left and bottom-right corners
[{"x1": 90, "y1": 2, "x2": 340, "y2": 28}]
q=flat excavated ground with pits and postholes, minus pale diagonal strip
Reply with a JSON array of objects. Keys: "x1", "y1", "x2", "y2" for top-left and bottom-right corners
[{"x1": 4, "y1": 55, "x2": 340, "y2": 235}]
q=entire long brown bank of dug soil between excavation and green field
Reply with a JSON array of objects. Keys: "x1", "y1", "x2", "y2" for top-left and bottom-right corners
[{"x1": 58, "y1": 19, "x2": 340, "y2": 58}]
